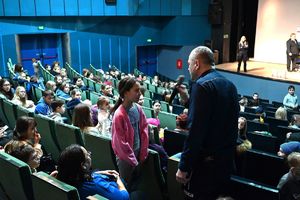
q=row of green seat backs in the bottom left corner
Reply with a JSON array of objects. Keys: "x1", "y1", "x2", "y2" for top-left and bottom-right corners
[{"x1": 0, "y1": 152, "x2": 106, "y2": 200}]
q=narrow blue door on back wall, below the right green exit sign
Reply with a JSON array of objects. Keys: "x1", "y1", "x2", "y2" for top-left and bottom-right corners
[{"x1": 137, "y1": 46, "x2": 157, "y2": 77}]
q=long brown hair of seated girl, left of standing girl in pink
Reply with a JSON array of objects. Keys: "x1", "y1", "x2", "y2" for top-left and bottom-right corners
[{"x1": 72, "y1": 103, "x2": 93, "y2": 130}]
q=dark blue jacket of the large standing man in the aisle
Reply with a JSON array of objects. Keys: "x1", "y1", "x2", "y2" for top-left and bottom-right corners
[{"x1": 179, "y1": 69, "x2": 239, "y2": 172}]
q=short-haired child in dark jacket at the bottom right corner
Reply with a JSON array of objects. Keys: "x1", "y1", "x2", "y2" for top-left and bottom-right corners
[{"x1": 277, "y1": 152, "x2": 300, "y2": 200}]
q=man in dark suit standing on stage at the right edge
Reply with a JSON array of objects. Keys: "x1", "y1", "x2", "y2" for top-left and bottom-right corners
[{"x1": 286, "y1": 33, "x2": 299, "y2": 72}]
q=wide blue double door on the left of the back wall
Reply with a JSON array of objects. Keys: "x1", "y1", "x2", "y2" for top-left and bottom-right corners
[{"x1": 19, "y1": 34, "x2": 58, "y2": 75}]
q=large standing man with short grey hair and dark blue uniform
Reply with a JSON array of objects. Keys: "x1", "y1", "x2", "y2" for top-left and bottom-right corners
[{"x1": 176, "y1": 46, "x2": 239, "y2": 200}]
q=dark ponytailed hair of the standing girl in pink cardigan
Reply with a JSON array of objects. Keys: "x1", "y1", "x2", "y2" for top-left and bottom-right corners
[{"x1": 110, "y1": 77, "x2": 137, "y2": 113}]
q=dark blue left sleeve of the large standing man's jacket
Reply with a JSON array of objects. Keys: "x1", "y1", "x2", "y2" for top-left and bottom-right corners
[{"x1": 179, "y1": 85, "x2": 213, "y2": 172}]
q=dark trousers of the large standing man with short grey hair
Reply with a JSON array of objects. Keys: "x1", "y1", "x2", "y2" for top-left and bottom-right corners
[{"x1": 184, "y1": 159, "x2": 233, "y2": 200}]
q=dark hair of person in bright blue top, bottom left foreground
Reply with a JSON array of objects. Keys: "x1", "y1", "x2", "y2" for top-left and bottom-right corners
[{"x1": 57, "y1": 144, "x2": 91, "y2": 187}]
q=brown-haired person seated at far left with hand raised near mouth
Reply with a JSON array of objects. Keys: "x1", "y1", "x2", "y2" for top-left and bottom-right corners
[{"x1": 4, "y1": 116, "x2": 43, "y2": 171}]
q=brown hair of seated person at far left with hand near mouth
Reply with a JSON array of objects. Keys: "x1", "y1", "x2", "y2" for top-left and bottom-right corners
[{"x1": 13, "y1": 116, "x2": 37, "y2": 140}]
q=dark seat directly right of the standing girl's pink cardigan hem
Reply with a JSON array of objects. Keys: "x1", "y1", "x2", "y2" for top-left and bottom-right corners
[{"x1": 137, "y1": 149, "x2": 166, "y2": 200}]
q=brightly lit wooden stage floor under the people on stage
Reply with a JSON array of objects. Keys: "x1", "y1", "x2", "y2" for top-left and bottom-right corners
[{"x1": 216, "y1": 59, "x2": 300, "y2": 83}]
